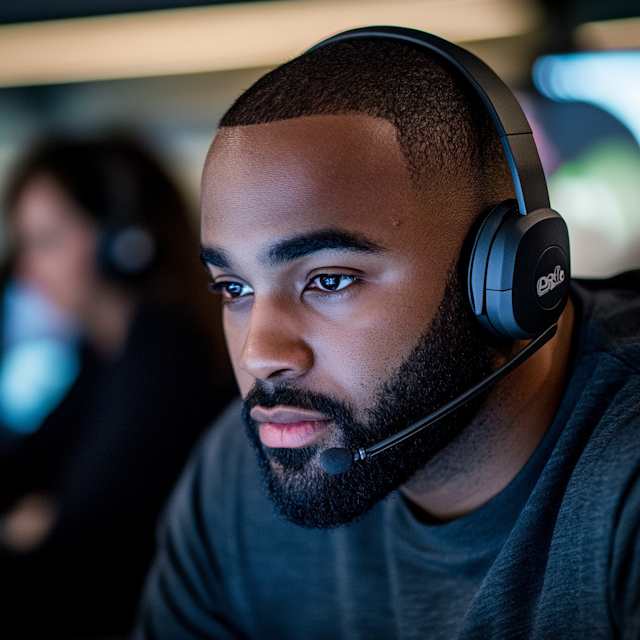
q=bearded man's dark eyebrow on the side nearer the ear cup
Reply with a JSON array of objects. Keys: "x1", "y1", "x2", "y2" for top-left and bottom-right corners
[{"x1": 263, "y1": 229, "x2": 383, "y2": 266}]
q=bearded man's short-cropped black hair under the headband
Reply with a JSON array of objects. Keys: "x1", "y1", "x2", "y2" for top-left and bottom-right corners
[{"x1": 220, "y1": 38, "x2": 513, "y2": 206}]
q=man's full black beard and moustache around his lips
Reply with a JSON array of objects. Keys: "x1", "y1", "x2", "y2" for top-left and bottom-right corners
[{"x1": 243, "y1": 276, "x2": 493, "y2": 529}]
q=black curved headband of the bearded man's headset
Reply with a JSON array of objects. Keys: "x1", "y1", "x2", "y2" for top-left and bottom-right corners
[{"x1": 309, "y1": 26, "x2": 549, "y2": 215}]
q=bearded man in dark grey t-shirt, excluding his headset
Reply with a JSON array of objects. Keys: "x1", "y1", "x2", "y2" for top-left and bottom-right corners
[{"x1": 137, "y1": 28, "x2": 640, "y2": 639}]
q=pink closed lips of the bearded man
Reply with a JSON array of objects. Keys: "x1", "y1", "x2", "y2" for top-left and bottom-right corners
[{"x1": 251, "y1": 405, "x2": 332, "y2": 449}]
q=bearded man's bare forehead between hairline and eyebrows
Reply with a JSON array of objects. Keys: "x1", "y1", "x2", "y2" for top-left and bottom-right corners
[{"x1": 202, "y1": 115, "x2": 456, "y2": 270}]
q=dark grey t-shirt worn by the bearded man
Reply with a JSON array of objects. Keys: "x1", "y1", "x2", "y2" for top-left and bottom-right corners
[{"x1": 134, "y1": 275, "x2": 640, "y2": 640}]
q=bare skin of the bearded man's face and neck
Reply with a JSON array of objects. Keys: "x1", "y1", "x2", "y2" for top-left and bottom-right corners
[{"x1": 202, "y1": 115, "x2": 574, "y2": 521}]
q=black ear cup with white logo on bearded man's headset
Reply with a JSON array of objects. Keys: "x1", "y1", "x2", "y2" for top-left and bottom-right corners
[{"x1": 468, "y1": 200, "x2": 570, "y2": 340}]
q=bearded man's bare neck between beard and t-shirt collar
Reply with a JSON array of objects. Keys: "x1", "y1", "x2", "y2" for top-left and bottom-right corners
[{"x1": 402, "y1": 301, "x2": 574, "y2": 522}]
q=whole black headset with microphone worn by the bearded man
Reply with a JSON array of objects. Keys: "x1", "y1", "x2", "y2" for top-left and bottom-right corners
[{"x1": 309, "y1": 26, "x2": 570, "y2": 474}]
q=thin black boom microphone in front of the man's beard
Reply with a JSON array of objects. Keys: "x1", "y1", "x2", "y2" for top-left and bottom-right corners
[{"x1": 320, "y1": 324, "x2": 558, "y2": 475}]
